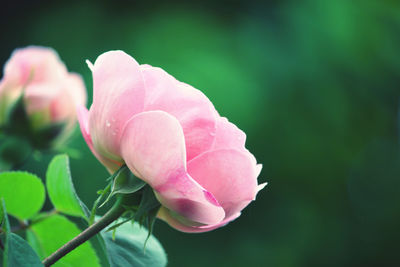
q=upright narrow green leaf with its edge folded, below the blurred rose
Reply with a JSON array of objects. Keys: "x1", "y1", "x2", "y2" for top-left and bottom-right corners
[{"x1": 46, "y1": 155, "x2": 89, "y2": 219}]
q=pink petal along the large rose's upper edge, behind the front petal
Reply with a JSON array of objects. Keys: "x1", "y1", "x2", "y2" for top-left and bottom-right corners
[{"x1": 141, "y1": 65, "x2": 218, "y2": 160}]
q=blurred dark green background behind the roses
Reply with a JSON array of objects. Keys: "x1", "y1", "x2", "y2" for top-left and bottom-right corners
[{"x1": 0, "y1": 0, "x2": 400, "y2": 267}]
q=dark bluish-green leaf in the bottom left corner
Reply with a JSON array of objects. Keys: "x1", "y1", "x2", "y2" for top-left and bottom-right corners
[{"x1": 1, "y1": 199, "x2": 43, "y2": 267}]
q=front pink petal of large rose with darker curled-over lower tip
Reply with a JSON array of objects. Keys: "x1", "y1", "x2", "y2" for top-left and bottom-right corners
[{"x1": 121, "y1": 111, "x2": 225, "y2": 224}]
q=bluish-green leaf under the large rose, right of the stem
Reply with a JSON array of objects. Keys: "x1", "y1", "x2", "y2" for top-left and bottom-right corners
[{"x1": 103, "y1": 223, "x2": 167, "y2": 267}]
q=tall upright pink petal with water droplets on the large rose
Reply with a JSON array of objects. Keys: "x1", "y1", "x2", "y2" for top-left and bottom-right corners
[{"x1": 89, "y1": 51, "x2": 145, "y2": 160}]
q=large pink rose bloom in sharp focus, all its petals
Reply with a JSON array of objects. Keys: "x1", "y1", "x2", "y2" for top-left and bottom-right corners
[{"x1": 78, "y1": 51, "x2": 265, "y2": 232}]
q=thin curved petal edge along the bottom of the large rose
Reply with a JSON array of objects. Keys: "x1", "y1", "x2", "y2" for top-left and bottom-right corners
[{"x1": 157, "y1": 207, "x2": 240, "y2": 233}]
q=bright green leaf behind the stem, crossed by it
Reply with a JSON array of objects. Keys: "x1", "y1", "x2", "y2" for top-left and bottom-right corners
[{"x1": 29, "y1": 215, "x2": 100, "y2": 267}]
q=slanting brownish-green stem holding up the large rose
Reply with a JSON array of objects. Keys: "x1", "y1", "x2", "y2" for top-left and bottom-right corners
[{"x1": 42, "y1": 197, "x2": 125, "y2": 267}]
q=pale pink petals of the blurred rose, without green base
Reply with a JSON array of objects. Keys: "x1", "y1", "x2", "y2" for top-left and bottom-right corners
[{"x1": 0, "y1": 46, "x2": 86, "y2": 133}]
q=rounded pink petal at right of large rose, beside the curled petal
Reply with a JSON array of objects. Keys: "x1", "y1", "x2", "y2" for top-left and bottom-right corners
[{"x1": 188, "y1": 149, "x2": 257, "y2": 220}]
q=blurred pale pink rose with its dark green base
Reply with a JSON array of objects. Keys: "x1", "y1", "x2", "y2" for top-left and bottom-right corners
[{"x1": 0, "y1": 46, "x2": 86, "y2": 150}]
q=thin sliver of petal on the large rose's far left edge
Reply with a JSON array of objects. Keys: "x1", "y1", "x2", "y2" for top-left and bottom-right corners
[{"x1": 77, "y1": 106, "x2": 122, "y2": 173}]
